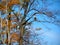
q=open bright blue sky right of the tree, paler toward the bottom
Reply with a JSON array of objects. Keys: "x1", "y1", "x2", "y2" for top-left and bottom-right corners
[{"x1": 33, "y1": 0, "x2": 60, "y2": 45}]
